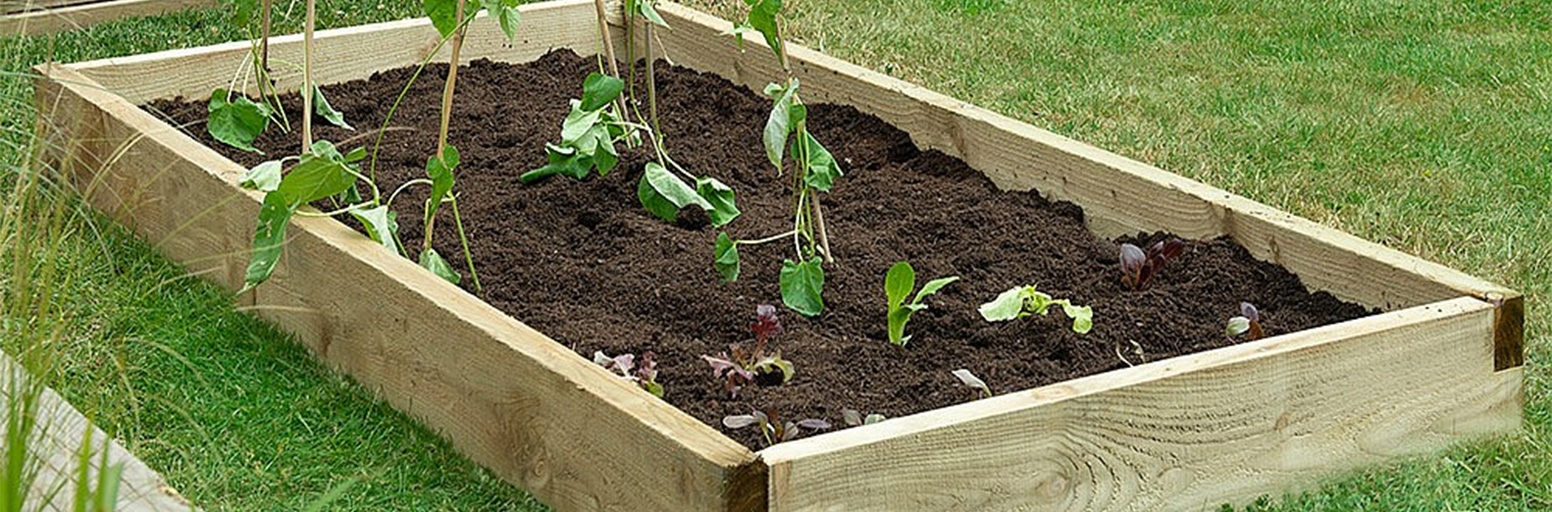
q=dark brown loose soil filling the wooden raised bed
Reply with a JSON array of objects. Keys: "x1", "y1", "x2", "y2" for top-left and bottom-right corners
[{"x1": 147, "y1": 50, "x2": 1370, "y2": 450}]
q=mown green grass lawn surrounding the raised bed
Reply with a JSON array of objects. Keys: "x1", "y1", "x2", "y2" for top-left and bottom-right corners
[{"x1": 0, "y1": 0, "x2": 1552, "y2": 510}]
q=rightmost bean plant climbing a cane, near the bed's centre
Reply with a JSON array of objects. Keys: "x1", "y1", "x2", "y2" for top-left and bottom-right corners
[{"x1": 712, "y1": 0, "x2": 841, "y2": 317}]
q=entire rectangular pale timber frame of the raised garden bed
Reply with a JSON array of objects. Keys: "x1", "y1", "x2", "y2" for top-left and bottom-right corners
[{"x1": 37, "y1": 0, "x2": 1524, "y2": 510}]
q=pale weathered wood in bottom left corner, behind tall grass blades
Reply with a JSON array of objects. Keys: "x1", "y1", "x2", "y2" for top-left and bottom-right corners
[{"x1": 0, "y1": 352, "x2": 194, "y2": 512}]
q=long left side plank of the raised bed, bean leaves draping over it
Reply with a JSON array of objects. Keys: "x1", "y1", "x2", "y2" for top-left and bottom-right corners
[{"x1": 37, "y1": 50, "x2": 765, "y2": 510}]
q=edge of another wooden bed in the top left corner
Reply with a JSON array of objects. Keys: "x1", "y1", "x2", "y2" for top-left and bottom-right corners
[{"x1": 0, "y1": 0, "x2": 219, "y2": 37}]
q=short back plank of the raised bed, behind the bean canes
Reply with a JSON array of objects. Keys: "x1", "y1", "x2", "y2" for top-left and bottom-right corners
[{"x1": 70, "y1": 0, "x2": 599, "y2": 104}]
